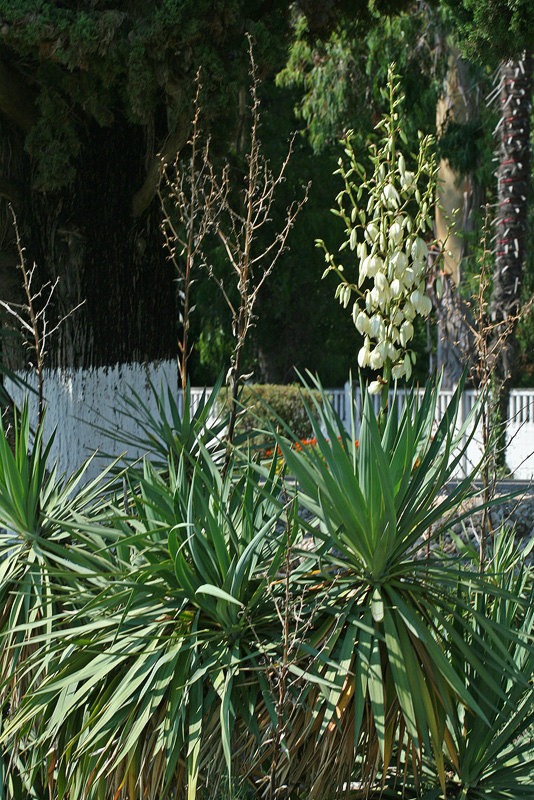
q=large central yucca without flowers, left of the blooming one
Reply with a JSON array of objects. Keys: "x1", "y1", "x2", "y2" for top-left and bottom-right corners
[{"x1": 5, "y1": 444, "x2": 306, "y2": 800}]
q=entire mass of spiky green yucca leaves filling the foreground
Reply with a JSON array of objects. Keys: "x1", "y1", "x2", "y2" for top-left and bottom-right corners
[{"x1": 0, "y1": 382, "x2": 533, "y2": 800}]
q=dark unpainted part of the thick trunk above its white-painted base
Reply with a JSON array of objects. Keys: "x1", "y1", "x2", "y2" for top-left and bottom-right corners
[{"x1": 0, "y1": 114, "x2": 177, "y2": 368}]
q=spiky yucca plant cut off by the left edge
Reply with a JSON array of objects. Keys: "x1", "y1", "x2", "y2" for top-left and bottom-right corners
[{"x1": 0, "y1": 405, "x2": 121, "y2": 798}]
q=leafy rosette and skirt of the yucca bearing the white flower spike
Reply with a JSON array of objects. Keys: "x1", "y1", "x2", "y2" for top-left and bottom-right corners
[{"x1": 258, "y1": 381, "x2": 527, "y2": 798}]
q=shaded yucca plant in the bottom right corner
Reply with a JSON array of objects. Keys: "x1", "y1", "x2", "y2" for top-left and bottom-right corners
[{"x1": 408, "y1": 531, "x2": 534, "y2": 800}]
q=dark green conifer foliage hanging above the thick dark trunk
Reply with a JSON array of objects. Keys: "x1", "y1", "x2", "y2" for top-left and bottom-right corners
[{"x1": 0, "y1": 0, "x2": 294, "y2": 189}]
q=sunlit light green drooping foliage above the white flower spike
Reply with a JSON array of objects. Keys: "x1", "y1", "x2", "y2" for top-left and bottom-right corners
[{"x1": 277, "y1": 7, "x2": 440, "y2": 152}]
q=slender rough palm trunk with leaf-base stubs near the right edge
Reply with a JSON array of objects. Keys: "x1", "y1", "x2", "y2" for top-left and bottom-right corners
[{"x1": 490, "y1": 55, "x2": 534, "y2": 440}]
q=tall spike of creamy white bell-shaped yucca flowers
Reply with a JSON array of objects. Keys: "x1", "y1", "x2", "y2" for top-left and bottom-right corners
[{"x1": 318, "y1": 68, "x2": 436, "y2": 393}]
